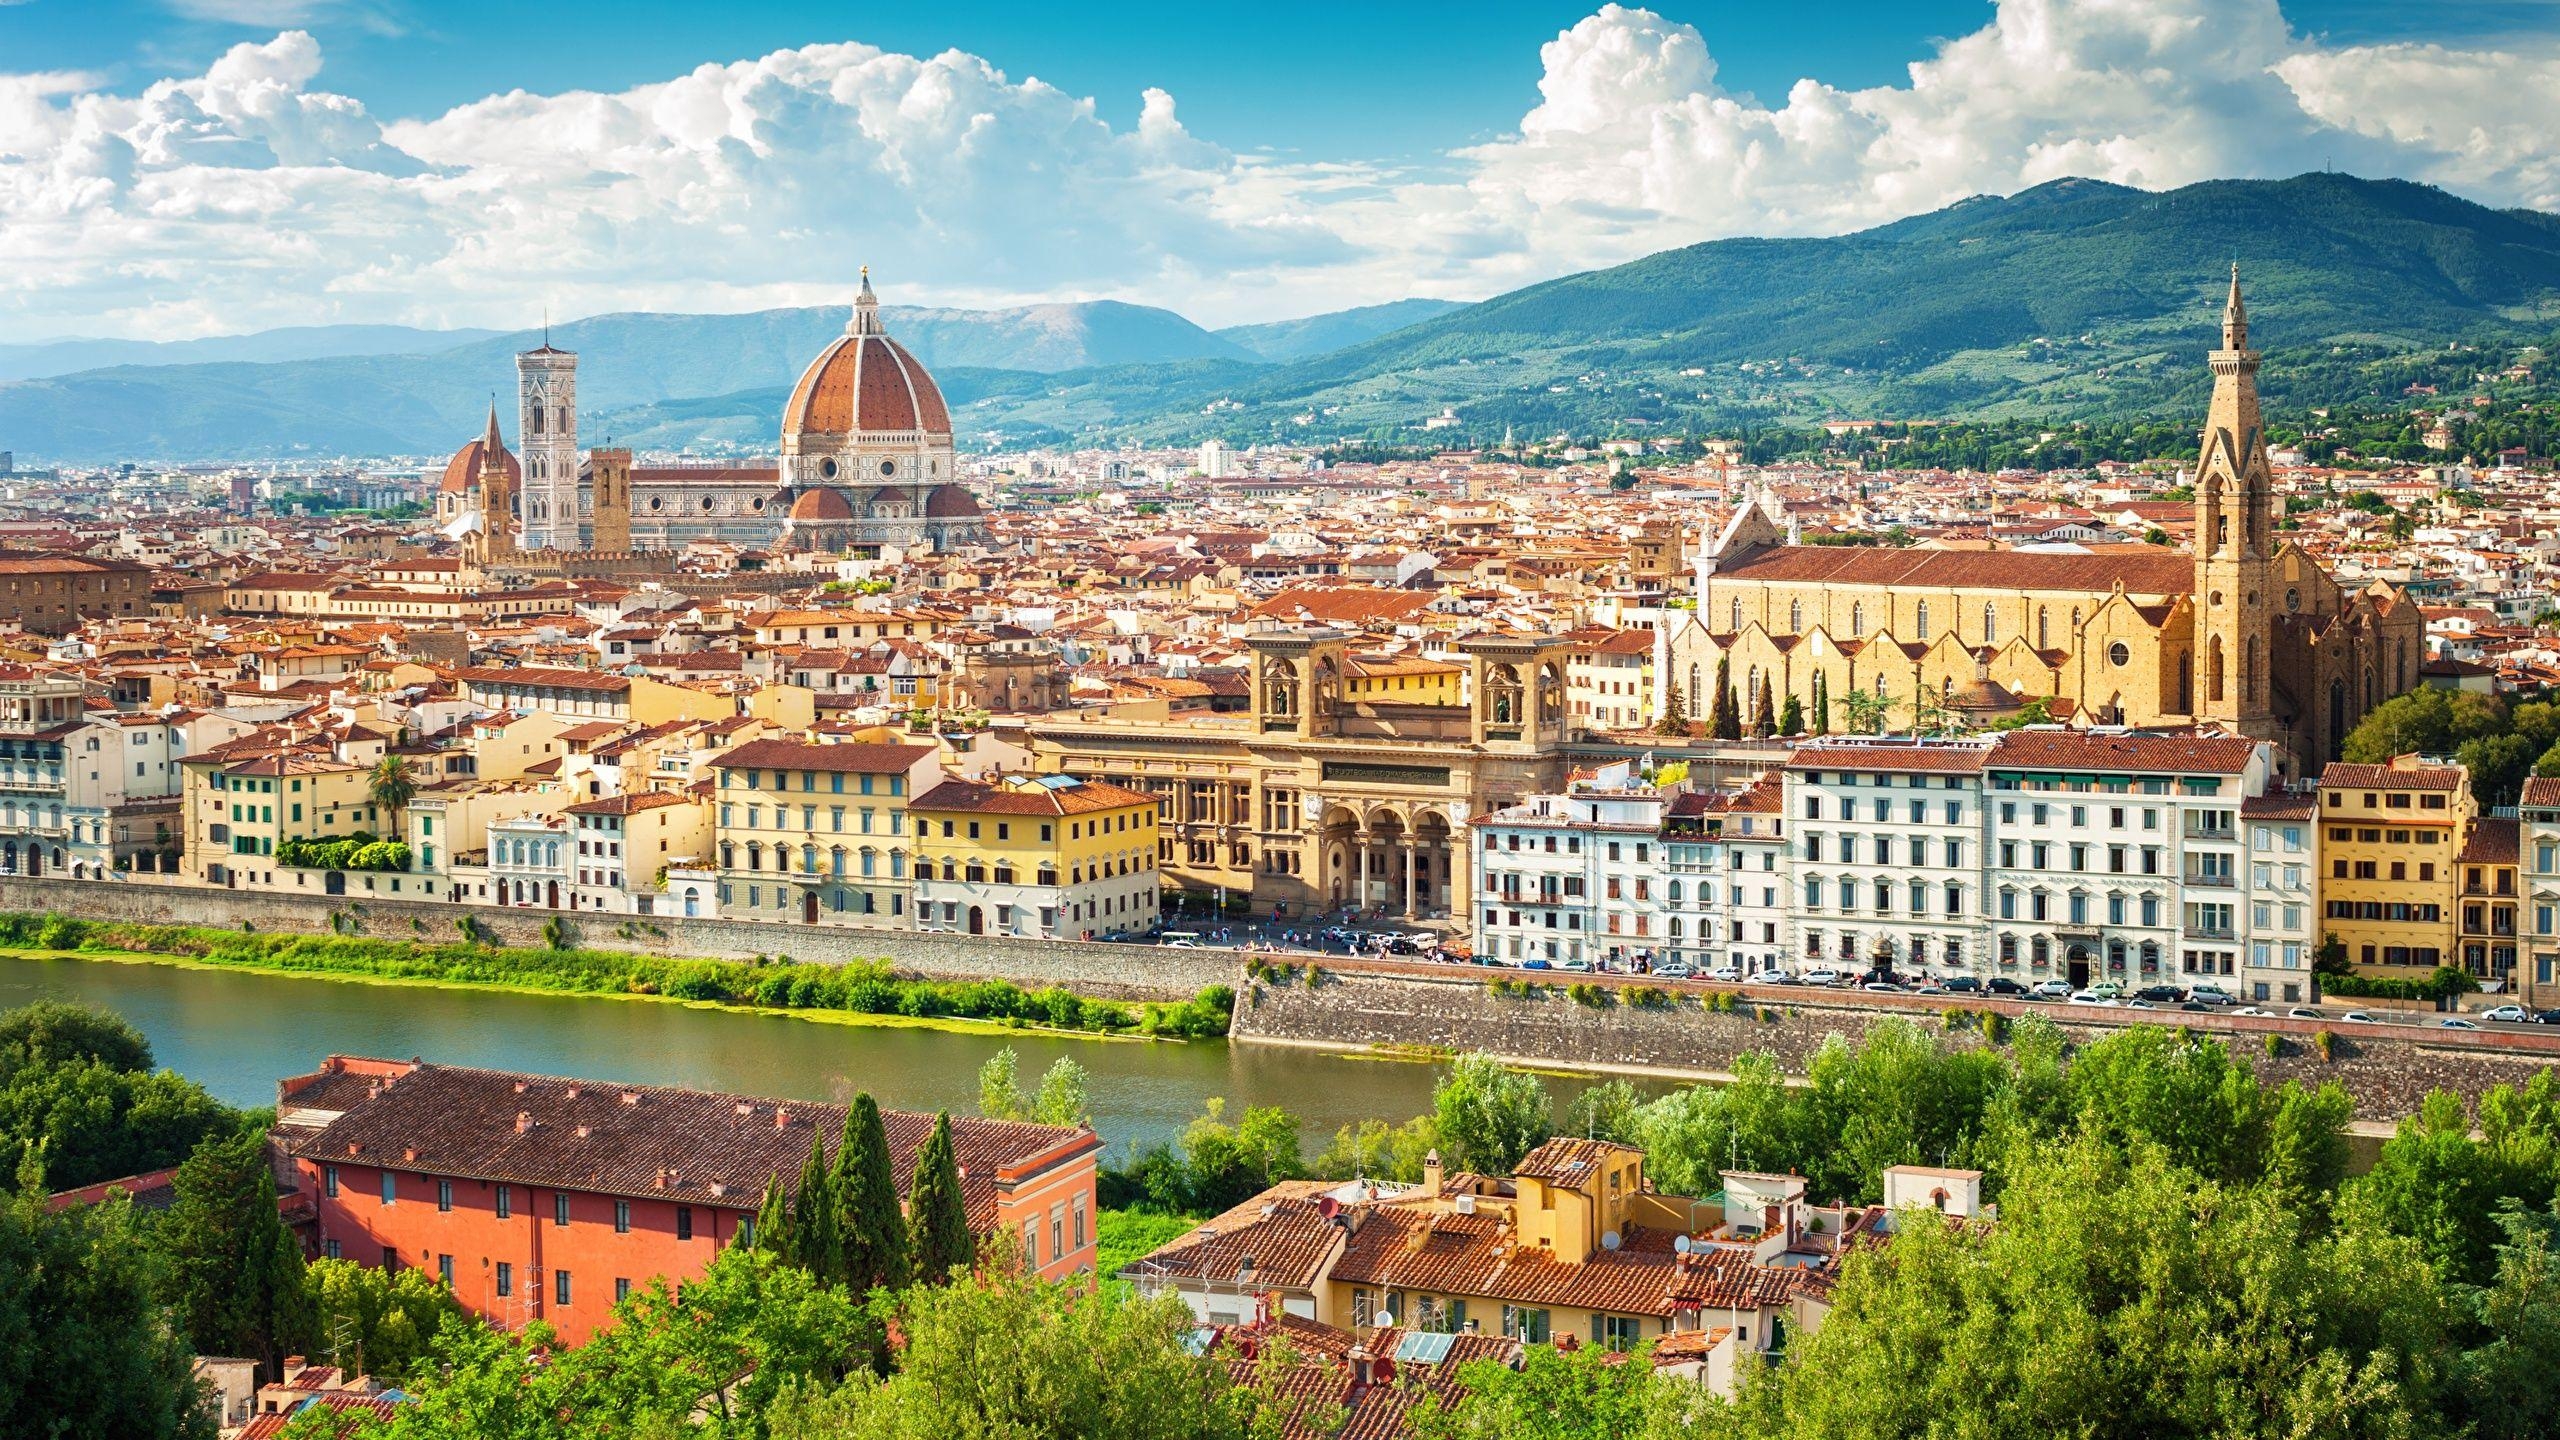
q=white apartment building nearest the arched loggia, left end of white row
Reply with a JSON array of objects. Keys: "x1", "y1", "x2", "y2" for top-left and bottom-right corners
[{"x1": 1472, "y1": 761, "x2": 1672, "y2": 966}]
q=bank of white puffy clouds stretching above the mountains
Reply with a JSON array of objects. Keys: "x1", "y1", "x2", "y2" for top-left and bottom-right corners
[{"x1": 0, "y1": 0, "x2": 2560, "y2": 338}]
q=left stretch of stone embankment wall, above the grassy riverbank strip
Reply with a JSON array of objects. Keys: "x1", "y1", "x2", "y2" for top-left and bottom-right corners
[{"x1": 0, "y1": 876, "x2": 1242, "y2": 999}]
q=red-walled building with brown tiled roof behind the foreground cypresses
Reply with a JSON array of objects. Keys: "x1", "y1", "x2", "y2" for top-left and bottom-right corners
[{"x1": 276, "y1": 1056, "x2": 1101, "y2": 1343}]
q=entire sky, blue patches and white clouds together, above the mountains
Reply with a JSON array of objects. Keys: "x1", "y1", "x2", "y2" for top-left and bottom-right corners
[{"x1": 0, "y1": 0, "x2": 2560, "y2": 341}]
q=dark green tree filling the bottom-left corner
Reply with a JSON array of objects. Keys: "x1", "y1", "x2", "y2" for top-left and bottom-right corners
[{"x1": 0, "y1": 1156, "x2": 215, "y2": 1440}]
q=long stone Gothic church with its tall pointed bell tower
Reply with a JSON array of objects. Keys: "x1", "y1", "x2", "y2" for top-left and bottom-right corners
[{"x1": 1659, "y1": 272, "x2": 2424, "y2": 774}]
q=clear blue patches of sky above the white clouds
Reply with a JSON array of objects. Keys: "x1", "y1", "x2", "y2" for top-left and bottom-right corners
[{"x1": 15, "y1": 0, "x2": 2560, "y2": 159}]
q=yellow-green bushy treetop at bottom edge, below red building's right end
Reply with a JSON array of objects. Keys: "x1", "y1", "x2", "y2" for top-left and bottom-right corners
[{"x1": 771, "y1": 1268, "x2": 1247, "y2": 1440}]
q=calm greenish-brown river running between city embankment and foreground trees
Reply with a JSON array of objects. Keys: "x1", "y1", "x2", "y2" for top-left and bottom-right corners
[{"x1": 0, "y1": 956, "x2": 1638, "y2": 1158}]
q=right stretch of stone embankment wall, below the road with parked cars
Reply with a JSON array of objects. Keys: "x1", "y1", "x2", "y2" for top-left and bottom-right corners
[{"x1": 1234, "y1": 966, "x2": 2560, "y2": 1120}]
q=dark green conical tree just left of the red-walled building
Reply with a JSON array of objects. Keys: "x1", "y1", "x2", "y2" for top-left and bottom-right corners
[{"x1": 151, "y1": 1130, "x2": 312, "y2": 1381}]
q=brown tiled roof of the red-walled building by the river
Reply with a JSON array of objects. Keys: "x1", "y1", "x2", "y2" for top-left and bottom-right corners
[{"x1": 282, "y1": 1061, "x2": 1101, "y2": 1230}]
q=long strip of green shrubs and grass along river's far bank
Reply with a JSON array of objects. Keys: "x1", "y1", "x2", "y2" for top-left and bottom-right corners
[{"x1": 0, "y1": 915, "x2": 1234, "y2": 1040}]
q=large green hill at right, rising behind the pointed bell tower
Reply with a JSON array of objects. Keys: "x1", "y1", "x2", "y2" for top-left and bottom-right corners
[{"x1": 1185, "y1": 174, "x2": 2560, "y2": 433}]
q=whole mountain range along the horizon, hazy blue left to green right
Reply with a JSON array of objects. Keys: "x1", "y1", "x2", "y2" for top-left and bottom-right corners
[{"x1": 0, "y1": 174, "x2": 2560, "y2": 459}]
